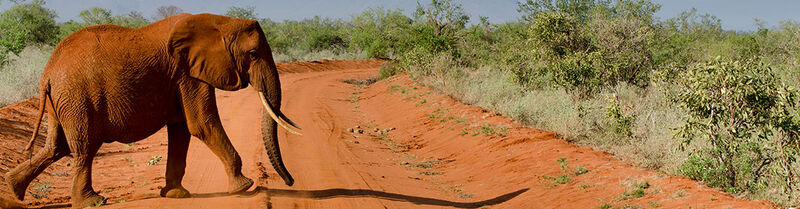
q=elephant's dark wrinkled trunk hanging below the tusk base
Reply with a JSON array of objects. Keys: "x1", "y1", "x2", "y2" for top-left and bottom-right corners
[{"x1": 260, "y1": 93, "x2": 294, "y2": 186}]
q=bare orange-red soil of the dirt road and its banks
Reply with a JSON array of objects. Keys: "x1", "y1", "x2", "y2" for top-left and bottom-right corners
[{"x1": 0, "y1": 60, "x2": 774, "y2": 208}]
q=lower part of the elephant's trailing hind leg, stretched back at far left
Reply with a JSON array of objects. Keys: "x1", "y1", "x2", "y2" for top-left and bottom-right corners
[{"x1": 5, "y1": 119, "x2": 69, "y2": 200}]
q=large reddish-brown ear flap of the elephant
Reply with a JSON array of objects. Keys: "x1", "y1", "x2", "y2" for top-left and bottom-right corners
[{"x1": 168, "y1": 14, "x2": 242, "y2": 90}]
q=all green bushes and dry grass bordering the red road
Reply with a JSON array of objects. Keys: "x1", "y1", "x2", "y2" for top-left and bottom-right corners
[{"x1": 0, "y1": 0, "x2": 800, "y2": 206}]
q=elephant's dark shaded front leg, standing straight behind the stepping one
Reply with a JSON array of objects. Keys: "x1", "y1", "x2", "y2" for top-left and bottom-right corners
[{"x1": 161, "y1": 122, "x2": 191, "y2": 198}]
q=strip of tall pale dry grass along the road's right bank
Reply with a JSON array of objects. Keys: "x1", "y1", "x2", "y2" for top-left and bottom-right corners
[{"x1": 410, "y1": 55, "x2": 686, "y2": 171}]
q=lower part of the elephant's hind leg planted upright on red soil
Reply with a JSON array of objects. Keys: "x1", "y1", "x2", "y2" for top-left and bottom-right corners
[{"x1": 67, "y1": 138, "x2": 106, "y2": 208}]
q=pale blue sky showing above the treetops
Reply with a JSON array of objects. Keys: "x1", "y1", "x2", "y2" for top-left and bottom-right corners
[{"x1": 0, "y1": 0, "x2": 800, "y2": 31}]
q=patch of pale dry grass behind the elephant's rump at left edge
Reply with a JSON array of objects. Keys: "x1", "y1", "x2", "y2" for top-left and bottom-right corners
[{"x1": 0, "y1": 46, "x2": 53, "y2": 106}]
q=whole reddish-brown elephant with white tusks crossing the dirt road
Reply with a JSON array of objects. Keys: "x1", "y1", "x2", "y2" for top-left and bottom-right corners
[{"x1": 5, "y1": 13, "x2": 301, "y2": 207}]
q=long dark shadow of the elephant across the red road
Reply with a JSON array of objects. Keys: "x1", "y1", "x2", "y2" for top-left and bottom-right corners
[{"x1": 192, "y1": 186, "x2": 530, "y2": 208}]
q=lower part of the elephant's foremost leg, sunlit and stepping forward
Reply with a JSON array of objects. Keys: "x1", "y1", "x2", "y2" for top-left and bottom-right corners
[{"x1": 195, "y1": 124, "x2": 253, "y2": 194}]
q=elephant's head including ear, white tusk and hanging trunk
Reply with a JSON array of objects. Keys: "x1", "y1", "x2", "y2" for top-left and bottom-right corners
[{"x1": 167, "y1": 14, "x2": 301, "y2": 186}]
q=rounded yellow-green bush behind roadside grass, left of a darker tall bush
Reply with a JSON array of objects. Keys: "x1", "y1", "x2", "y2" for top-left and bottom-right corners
[{"x1": 505, "y1": 12, "x2": 601, "y2": 95}]
